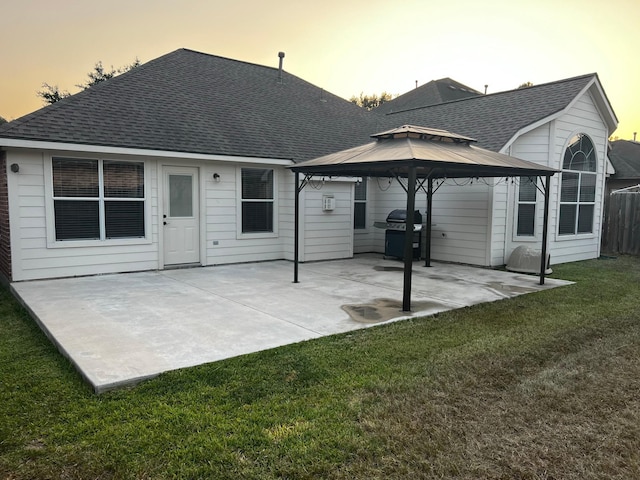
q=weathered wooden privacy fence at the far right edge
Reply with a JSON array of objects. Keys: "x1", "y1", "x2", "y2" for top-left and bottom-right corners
[{"x1": 602, "y1": 192, "x2": 640, "y2": 255}]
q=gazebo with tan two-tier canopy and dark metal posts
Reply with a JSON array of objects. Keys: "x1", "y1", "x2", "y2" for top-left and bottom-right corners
[{"x1": 289, "y1": 125, "x2": 557, "y2": 312}]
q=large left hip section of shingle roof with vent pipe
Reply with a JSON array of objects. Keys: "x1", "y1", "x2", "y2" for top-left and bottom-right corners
[{"x1": 0, "y1": 49, "x2": 378, "y2": 161}]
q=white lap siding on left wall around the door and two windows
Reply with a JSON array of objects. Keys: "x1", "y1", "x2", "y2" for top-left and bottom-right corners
[{"x1": 7, "y1": 149, "x2": 296, "y2": 281}]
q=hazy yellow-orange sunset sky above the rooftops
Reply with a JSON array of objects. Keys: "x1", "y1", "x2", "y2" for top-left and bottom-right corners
[{"x1": 0, "y1": 0, "x2": 640, "y2": 139}]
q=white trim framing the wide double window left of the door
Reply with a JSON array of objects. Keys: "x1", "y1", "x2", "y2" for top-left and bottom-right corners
[{"x1": 44, "y1": 154, "x2": 151, "y2": 248}]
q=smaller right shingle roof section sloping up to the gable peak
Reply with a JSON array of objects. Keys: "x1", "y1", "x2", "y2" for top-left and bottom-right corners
[{"x1": 386, "y1": 74, "x2": 595, "y2": 151}]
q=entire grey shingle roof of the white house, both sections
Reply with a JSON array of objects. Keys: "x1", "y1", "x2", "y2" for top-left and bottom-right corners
[{"x1": 0, "y1": 49, "x2": 595, "y2": 158}]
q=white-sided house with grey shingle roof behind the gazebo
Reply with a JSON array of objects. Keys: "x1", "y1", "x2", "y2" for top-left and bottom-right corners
[{"x1": 0, "y1": 49, "x2": 617, "y2": 281}]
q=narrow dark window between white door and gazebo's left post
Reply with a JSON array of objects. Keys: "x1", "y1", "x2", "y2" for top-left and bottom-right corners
[{"x1": 241, "y1": 168, "x2": 275, "y2": 233}]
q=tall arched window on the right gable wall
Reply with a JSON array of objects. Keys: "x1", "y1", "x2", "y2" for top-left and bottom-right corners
[{"x1": 558, "y1": 134, "x2": 597, "y2": 235}]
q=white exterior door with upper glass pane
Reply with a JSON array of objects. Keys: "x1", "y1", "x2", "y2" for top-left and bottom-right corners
[{"x1": 162, "y1": 167, "x2": 200, "y2": 265}]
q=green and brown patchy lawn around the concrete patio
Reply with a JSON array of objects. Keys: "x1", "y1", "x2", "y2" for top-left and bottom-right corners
[{"x1": 0, "y1": 257, "x2": 640, "y2": 479}]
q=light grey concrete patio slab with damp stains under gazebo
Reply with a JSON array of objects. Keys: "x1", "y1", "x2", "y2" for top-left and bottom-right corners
[{"x1": 11, "y1": 255, "x2": 571, "y2": 392}]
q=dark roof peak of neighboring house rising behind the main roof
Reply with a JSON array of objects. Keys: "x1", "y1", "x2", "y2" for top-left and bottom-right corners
[{"x1": 376, "y1": 77, "x2": 482, "y2": 114}]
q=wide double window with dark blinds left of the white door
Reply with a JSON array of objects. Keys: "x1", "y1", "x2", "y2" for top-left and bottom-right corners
[{"x1": 51, "y1": 158, "x2": 145, "y2": 241}]
